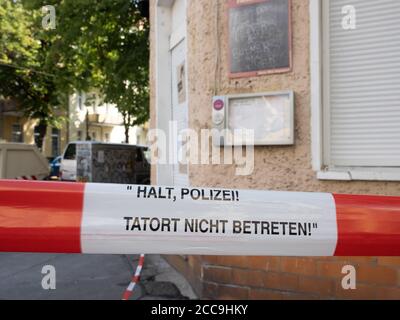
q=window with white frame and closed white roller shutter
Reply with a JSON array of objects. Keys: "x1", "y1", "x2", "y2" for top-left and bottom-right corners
[{"x1": 311, "y1": 0, "x2": 400, "y2": 180}]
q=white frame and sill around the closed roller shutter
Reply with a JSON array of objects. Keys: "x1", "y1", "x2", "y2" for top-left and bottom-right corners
[{"x1": 310, "y1": 0, "x2": 400, "y2": 181}]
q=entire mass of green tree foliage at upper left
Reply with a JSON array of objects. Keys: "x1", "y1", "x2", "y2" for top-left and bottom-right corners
[{"x1": 0, "y1": 0, "x2": 149, "y2": 144}]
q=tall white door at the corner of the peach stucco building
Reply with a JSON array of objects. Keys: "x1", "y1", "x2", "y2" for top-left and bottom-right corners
[{"x1": 155, "y1": 0, "x2": 189, "y2": 186}]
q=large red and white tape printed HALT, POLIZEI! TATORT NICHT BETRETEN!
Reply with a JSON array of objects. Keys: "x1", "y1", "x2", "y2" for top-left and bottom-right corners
[{"x1": 0, "y1": 180, "x2": 400, "y2": 256}]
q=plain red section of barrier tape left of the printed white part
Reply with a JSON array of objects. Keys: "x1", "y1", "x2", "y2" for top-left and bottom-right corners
[{"x1": 0, "y1": 180, "x2": 85, "y2": 253}]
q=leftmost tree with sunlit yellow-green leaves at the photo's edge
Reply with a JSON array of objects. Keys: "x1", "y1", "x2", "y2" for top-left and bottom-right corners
[{"x1": 0, "y1": 0, "x2": 65, "y2": 148}]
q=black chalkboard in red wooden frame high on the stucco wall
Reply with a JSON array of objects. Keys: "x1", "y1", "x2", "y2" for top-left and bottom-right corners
[{"x1": 229, "y1": 0, "x2": 292, "y2": 77}]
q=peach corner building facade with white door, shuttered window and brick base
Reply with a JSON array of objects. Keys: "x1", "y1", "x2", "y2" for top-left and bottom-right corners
[{"x1": 150, "y1": 0, "x2": 400, "y2": 299}]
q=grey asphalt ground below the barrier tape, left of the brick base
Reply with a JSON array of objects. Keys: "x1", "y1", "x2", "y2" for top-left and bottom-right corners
[{"x1": 0, "y1": 253, "x2": 195, "y2": 300}]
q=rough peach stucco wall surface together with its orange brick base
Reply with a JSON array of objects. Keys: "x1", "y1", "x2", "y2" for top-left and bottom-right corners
[{"x1": 150, "y1": 0, "x2": 400, "y2": 299}]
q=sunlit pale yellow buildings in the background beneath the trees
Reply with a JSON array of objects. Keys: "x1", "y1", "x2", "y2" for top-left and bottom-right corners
[{"x1": 0, "y1": 93, "x2": 148, "y2": 159}]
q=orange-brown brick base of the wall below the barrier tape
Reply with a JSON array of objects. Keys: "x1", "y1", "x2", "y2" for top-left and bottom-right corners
[{"x1": 167, "y1": 256, "x2": 400, "y2": 300}]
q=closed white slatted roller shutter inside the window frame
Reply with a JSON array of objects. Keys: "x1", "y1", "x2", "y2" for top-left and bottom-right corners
[{"x1": 322, "y1": 0, "x2": 400, "y2": 167}]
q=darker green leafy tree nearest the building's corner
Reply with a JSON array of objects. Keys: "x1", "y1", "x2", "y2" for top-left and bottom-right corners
[{"x1": 23, "y1": 0, "x2": 149, "y2": 142}]
